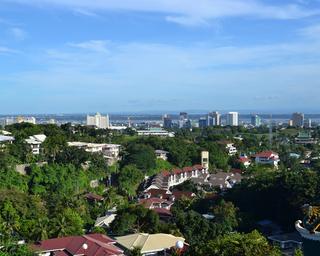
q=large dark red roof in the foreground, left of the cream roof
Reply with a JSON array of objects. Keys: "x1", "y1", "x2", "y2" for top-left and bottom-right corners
[{"x1": 33, "y1": 234, "x2": 124, "y2": 256}]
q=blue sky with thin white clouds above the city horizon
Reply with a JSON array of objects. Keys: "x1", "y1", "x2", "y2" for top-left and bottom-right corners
[{"x1": 0, "y1": 0, "x2": 320, "y2": 114}]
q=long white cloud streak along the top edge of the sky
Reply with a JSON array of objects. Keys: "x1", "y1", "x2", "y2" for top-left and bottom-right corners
[{"x1": 5, "y1": 0, "x2": 320, "y2": 25}]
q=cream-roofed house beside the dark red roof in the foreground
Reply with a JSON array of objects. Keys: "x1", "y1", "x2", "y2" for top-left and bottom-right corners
[{"x1": 116, "y1": 233, "x2": 185, "y2": 256}]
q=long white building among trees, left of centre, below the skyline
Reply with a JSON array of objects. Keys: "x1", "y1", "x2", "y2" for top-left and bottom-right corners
[{"x1": 68, "y1": 141, "x2": 121, "y2": 165}]
